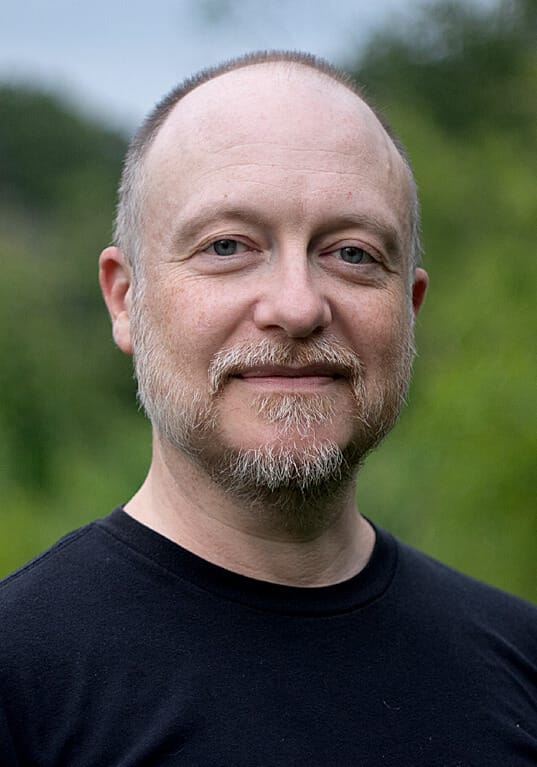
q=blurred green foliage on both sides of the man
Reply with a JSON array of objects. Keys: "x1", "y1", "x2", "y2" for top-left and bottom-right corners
[{"x1": 0, "y1": 0, "x2": 537, "y2": 601}]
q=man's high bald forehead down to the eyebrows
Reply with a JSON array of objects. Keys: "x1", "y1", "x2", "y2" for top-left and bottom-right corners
[{"x1": 141, "y1": 62, "x2": 409, "y2": 246}]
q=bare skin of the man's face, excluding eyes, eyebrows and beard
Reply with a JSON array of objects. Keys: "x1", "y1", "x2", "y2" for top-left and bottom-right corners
[{"x1": 138, "y1": 67, "x2": 422, "y2": 446}]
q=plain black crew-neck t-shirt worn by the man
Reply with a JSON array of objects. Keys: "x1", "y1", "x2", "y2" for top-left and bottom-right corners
[{"x1": 0, "y1": 509, "x2": 537, "y2": 767}]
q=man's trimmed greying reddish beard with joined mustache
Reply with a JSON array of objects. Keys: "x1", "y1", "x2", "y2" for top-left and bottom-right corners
[{"x1": 131, "y1": 296, "x2": 414, "y2": 532}]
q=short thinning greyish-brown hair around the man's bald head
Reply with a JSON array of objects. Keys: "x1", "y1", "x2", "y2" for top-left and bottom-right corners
[{"x1": 114, "y1": 51, "x2": 421, "y2": 284}]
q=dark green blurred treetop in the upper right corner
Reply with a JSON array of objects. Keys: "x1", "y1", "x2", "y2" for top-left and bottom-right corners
[{"x1": 351, "y1": 0, "x2": 537, "y2": 136}]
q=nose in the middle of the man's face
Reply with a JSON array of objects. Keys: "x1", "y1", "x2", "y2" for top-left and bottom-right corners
[{"x1": 254, "y1": 254, "x2": 332, "y2": 338}]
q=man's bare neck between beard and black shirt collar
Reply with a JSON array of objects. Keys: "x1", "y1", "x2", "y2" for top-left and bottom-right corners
[{"x1": 125, "y1": 440, "x2": 374, "y2": 587}]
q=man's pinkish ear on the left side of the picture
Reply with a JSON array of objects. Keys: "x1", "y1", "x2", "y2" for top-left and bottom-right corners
[{"x1": 99, "y1": 247, "x2": 132, "y2": 354}]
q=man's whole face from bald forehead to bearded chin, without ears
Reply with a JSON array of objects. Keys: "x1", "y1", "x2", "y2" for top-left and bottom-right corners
[{"x1": 127, "y1": 65, "x2": 426, "y2": 504}]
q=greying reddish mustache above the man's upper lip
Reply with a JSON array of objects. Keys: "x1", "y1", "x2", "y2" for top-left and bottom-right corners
[{"x1": 209, "y1": 337, "x2": 364, "y2": 394}]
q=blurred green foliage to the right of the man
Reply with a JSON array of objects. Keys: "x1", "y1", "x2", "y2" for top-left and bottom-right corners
[{"x1": 355, "y1": 3, "x2": 537, "y2": 599}]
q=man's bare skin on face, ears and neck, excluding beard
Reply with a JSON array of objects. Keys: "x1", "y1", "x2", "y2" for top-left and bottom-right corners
[{"x1": 101, "y1": 64, "x2": 426, "y2": 585}]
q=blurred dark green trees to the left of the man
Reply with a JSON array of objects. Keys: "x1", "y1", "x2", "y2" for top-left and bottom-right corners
[{"x1": 0, "y1": 85, "x2": 147, "y2": 556}]
